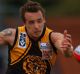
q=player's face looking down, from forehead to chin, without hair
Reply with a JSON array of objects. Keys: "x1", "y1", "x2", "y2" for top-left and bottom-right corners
[{"x1": 25, "y1": 11, "x2": 45, "y2": 38}]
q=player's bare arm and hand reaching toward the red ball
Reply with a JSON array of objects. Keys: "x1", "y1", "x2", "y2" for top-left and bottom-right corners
[{"x1": 51, "y1": 32, "x2": 73, "y2": 55}]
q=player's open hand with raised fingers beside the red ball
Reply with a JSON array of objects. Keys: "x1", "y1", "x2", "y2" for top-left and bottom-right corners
[{"x1": 61, "y1": 30, "x2": 73, "y2": 56}]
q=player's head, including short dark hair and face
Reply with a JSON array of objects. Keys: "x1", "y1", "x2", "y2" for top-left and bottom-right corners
[{"x1": 21, "y1": 1, "x2": 45, "y2": 38}]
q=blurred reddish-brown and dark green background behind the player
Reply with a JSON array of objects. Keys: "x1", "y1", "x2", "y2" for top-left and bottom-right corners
[{"x1": 0, "y1": 0, "x2": 80, "y2": 74}]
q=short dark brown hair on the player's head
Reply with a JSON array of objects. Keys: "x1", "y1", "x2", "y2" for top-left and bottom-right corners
[{"x1": 20, "y1": 1, "x2": 45, "y2": 22}]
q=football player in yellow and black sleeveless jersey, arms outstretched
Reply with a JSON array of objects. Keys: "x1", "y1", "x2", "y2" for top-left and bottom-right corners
[{"x1": 0, "y1": 1, "x2": 73, "y2": 74}]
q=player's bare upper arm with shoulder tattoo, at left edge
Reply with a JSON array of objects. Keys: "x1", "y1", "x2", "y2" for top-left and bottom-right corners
[{"x1": 0, "y1": 28, "x2": 16, "y2": 45}]
